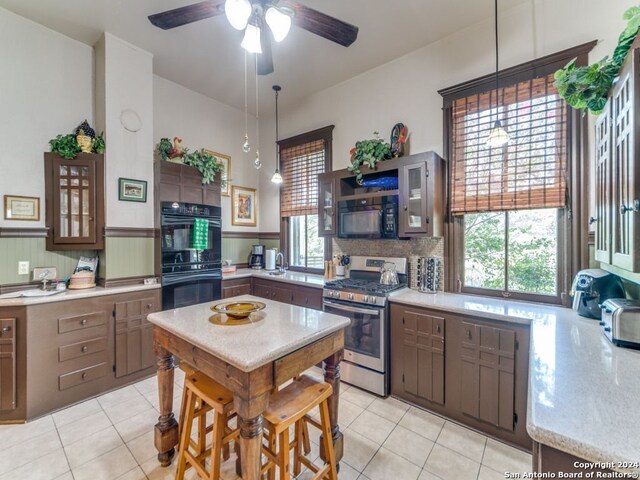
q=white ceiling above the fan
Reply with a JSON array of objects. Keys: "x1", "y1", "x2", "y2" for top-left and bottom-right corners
[{"x1": 0, "y1": 0, "x2": 530, "y2": 110}]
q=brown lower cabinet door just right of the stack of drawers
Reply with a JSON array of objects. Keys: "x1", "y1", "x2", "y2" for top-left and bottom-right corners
[{"x1": 115, "y1": 298, "x2": 158, "y2": 377}]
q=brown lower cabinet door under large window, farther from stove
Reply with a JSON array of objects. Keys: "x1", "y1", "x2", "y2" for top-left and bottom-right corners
[{"x1": 460, "y1": 322, "x2": 516, "y2": 431}]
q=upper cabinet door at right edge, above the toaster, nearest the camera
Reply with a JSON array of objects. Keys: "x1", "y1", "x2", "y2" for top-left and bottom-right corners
[{"x1": 610, "y1": 49, "x2": 640, "y2": 272}]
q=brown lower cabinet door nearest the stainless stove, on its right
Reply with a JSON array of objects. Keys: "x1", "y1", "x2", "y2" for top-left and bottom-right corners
[{"x1": 402, "y1": 310, "x2": 445, "y2": 404}]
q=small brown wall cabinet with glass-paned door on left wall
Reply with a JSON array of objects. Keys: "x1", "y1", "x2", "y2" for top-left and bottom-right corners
[{"x1": 44, "y1": 153, "x2": 104, "y2": 250}]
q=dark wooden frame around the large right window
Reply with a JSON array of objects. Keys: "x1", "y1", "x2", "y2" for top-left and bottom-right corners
[{"x1": 438, "y1": 40, "x2": 597, "y2": 306}]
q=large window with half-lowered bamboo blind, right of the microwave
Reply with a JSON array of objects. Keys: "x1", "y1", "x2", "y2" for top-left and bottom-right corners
[{"x1": 440, "y1": 44, "x2": 593, "y2": 303}]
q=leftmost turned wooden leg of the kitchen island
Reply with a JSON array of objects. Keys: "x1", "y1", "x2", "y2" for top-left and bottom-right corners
[{"x1": 154, "y1": 343, "x2": 178, "y2": 467}]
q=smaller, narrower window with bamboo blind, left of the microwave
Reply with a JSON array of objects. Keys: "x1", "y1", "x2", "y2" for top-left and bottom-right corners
[{"x1": 278, "y1": 126, "x2": 333, "y2": 271}]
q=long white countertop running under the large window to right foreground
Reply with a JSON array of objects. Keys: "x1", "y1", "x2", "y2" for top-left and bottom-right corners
[{"x1": 391, "y1": 290, "x2": 640, "y2": 472}]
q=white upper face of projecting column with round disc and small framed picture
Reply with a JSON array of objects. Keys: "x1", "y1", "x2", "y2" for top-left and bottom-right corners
[{"x1": 96, "y1": 32, "x2": 154, "y2": 228}]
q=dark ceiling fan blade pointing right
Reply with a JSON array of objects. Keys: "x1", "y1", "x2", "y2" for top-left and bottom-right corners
[{"x1": 279, "y1": 0, "x2": 358, "y2": 47}]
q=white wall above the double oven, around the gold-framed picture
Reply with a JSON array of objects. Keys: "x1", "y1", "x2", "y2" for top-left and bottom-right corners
[{"x1": 153, "y1": 75, "x2": 262, "y2": 231}]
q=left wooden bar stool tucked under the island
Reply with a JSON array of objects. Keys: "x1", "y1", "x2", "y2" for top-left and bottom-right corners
[{"x1": 176, "y1": 372, "x2": 240, "y2": 480}]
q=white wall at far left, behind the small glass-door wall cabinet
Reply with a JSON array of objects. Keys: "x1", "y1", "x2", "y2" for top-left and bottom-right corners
[{"x1": 0, "y1": 8, "x2": 93, "y2": 227}]
